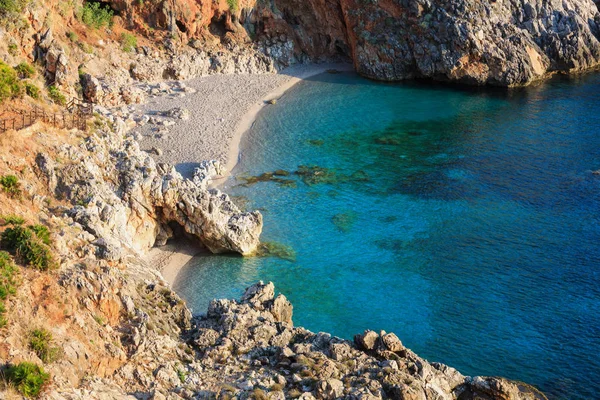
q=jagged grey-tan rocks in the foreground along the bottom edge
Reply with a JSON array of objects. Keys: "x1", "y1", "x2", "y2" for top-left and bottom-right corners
[{"x1": 95, "y1": 282, "x2": 545, "y2": 400}]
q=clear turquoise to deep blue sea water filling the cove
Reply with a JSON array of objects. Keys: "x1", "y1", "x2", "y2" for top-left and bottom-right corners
[{"x1": 175, "y1": 73, "x2": 600, "y2": 399}]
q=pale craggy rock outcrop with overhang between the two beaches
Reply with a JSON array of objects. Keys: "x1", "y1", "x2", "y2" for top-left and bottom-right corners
[{"x1": 36, "y1": 120, "x2": 262, "y2": 259}]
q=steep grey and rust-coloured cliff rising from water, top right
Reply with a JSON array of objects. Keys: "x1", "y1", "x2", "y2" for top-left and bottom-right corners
[{"x1": 255, "y1": 0, "x2": 600, "y2": 86}]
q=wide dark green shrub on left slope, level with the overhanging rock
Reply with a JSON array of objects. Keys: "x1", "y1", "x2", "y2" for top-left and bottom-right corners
[{"x1": 1, "y1": 225, "x2": 55, "y2": 271}]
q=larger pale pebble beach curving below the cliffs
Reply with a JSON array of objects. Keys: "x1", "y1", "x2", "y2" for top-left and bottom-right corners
[{"x1": 130, "y1": 63, "x2": 353, "y2": 180}]
